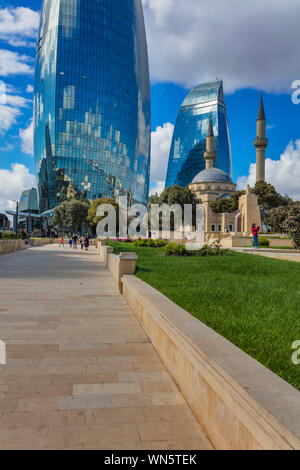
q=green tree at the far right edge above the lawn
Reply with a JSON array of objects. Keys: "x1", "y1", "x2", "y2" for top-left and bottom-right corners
[{"x1": 268, "y1": 202, "x2": 300, "y2": 250}]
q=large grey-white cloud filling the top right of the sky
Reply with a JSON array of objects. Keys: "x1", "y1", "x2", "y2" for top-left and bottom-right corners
[{"x1": 143, "y1": 0, "x2": 300, "y2": 92}]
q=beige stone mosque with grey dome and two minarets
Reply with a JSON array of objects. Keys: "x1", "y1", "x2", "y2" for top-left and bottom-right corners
[{"x1": 189, "y1": 95, "x2": 268, "y2": 237}]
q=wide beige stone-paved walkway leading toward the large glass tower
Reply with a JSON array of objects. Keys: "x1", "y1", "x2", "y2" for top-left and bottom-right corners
[{"x1": 0, "y1": 245, "x2": 211, "y2": 450}]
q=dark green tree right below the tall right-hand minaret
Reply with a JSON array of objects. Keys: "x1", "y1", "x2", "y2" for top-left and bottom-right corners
[{"x1": 252, "y1": 181, "x2": 292, "y2": 226}]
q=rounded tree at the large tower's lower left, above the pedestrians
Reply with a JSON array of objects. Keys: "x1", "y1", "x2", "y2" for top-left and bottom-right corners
[{"x1": 51, "y1": 199, "x2": 90, "y2": 233}]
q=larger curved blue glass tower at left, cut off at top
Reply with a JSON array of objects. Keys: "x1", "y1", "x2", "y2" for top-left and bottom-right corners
[{"x1": 34, "y1": 0, "x2": 151, "y2": 211}]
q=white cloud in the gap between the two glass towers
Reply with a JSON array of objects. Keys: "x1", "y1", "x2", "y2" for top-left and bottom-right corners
[{"x1": 150, "y1": 122, "x2": 174, "y2": 194}]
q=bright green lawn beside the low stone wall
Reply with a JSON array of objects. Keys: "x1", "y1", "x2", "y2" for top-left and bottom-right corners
[{"x1": 109, "y1": 242, "x2": 300, "y2": 390}]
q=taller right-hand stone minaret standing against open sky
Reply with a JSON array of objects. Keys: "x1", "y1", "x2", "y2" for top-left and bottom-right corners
[{"x1": 254, "y1": 93, "x2": 268, "y2": 183}]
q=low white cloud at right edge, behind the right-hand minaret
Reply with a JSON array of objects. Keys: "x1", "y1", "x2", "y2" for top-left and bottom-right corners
[{"x1": 237, "y1": 140, "x2": 300, "y2": 200}]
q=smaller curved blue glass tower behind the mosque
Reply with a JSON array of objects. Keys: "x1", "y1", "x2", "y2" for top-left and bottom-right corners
[{"x1": 166, "y1": 80, "x2": 232, "y2": 188}]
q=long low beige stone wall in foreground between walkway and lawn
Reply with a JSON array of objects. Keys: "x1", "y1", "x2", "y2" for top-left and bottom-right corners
[{"x1": 122, "y1": 276, "x2": 300, "y2": 450}]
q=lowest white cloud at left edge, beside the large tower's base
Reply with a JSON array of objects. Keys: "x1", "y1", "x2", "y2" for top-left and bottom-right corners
[{"x1": 0, "y1": 163, "x2": 36, "y2": 212}]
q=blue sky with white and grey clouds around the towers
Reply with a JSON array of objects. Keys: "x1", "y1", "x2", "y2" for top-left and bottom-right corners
[{"x1": 0, "y1": 0, "x2": 300, "y2": 212}]
